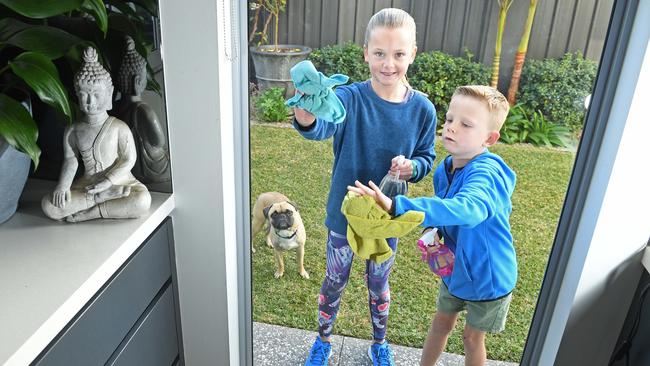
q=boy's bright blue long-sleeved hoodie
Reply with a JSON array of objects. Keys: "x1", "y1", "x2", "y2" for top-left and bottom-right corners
[{"x1": 394, "y1": 149, "x2": 517, "y2": 301}]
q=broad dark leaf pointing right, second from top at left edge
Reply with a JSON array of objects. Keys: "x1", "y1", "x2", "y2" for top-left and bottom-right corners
[{"x1": 0, "y1": 19, "x2": 85, "y2": 59}]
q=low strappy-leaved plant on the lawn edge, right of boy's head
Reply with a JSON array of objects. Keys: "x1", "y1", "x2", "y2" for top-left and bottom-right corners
[{"x1": 500, "y1": 104, "x2": 571, "y2": 147}]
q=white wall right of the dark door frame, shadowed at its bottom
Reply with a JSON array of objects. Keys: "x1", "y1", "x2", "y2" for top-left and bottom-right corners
[{"x1": 554, "y1": 0, "x2": 650, "y2": 366}]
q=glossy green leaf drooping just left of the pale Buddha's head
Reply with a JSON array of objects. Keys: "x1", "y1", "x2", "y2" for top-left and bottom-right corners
[{"x1": 9, "y1": 52, "x2": 72, "y2": 122}]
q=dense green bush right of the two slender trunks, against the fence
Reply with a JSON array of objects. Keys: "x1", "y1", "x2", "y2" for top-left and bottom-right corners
[{"x1": 517, "y1": 53, "x2": 598, "y2": 131}]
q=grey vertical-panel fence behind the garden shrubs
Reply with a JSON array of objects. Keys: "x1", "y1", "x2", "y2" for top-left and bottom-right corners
[{"x1": 251, "y1": 0, "x2": 614, "y2": 90}]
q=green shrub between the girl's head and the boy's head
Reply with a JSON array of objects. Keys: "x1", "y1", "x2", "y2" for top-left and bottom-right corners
[{"x1": 408, "y1": 51, "x2": 490, "y2": 121}]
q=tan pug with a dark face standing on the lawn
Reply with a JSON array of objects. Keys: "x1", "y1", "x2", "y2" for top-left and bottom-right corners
[{"x1": 251, "y1": 192, "x2": 309, "y2": 279}]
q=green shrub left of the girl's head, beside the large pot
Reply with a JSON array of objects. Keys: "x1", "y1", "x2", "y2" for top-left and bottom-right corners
[{"x1": 309, "y1": 42, "x2": 370, "y2": 83}]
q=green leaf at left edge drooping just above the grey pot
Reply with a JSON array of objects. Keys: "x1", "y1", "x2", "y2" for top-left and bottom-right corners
[{"x1": 0, "y1": 94, "x2": 41, "y2": 169}]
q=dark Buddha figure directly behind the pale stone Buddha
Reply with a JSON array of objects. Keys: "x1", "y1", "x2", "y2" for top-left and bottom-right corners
[{"x1": 114, "y1": 36, "x2": 171, "y2": 183}]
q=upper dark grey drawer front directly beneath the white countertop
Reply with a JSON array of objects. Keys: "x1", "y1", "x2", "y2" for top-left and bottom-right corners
[{"x1": 35, "y1": 220, "x2": 171, "y2": 366}]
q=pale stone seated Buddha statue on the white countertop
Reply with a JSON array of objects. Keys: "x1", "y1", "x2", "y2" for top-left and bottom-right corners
[{"x1": 41, "y1": 47, "x2": 151, "y2": 222}]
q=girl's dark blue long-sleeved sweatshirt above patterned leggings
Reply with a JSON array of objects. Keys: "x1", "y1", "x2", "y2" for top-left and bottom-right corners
[{"x1": 293, "y1": 81, "x2": 436, "y2": 234}]
